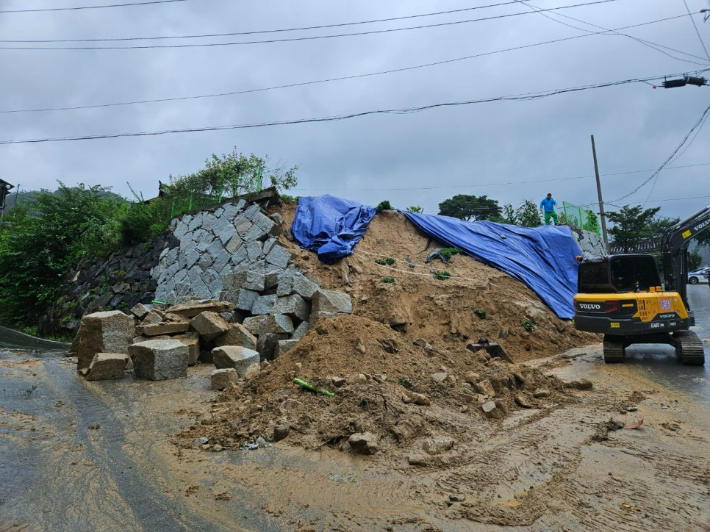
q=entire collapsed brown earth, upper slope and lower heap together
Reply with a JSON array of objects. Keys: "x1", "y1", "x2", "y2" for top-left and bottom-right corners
[{"x1": 176, "y1": 205, "x2": 598, "y2": 458}]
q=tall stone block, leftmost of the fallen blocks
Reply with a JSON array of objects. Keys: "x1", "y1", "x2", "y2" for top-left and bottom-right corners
[{"x1": 76, "y1": 310, "x2": 135, "y2": 371}]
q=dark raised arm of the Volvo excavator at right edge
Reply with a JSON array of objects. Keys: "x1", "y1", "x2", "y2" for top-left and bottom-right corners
[{"x1": 661, "y1": 205, "x2": 710, "y2": 308}]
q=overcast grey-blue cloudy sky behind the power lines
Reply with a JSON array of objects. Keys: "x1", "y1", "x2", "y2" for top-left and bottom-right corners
[{"x1": 0, "y1": 0, "x2": 710, "y2": 220}]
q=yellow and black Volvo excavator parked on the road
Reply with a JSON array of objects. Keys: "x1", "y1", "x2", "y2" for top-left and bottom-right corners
[{"x1": 574, "y1": 206, "x2": 710, "y2": 366}]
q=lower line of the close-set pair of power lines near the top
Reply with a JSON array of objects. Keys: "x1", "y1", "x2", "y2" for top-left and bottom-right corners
[{"x1": 0, "y1": 0, "x2": 624, "y2": 50}]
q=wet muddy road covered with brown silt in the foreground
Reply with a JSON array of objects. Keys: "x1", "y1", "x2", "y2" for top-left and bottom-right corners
[{"x1": 0, "y1": 285, "x2": 710, "y2": 531}]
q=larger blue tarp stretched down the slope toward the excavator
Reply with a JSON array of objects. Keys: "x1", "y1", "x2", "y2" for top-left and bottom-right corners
[{"x1": 404, "y1": 212, "x2": 582, "y2": 319}]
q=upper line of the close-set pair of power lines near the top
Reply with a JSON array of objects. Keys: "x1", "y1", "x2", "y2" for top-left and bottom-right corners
[{"x1": 0, "y1": 0, "x2": 528, "y2": 43}]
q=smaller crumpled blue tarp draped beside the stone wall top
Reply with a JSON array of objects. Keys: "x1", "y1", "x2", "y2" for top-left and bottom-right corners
[{"x1": 291, "y1": 195, "x2": 376, "y2": 264}]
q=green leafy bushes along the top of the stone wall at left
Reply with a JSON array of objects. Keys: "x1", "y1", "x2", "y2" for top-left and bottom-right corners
[{"x1": 0, "y1": 150, "x2": 297, "y2": 326}]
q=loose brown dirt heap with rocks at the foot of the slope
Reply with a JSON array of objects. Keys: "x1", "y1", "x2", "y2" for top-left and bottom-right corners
[{"x1": 176, "y1": 316, "x2": 575, "y2": 458}]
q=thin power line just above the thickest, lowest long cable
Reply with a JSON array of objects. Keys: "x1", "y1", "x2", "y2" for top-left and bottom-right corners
[{"x1": 0, "y1": 15, "x2": 687, "y2": 114}]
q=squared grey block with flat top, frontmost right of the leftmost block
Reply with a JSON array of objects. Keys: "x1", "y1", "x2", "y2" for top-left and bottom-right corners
[{"x1": 128, "y1": 340, "x2": 190, "y2": 381}]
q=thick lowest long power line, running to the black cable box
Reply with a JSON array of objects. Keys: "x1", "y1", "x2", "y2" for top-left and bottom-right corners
[{"x1": 0, "y1": 69, "x2": 710, "y2": 145}]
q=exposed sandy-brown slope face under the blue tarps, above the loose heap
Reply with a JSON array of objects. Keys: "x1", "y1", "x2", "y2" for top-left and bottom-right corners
[{"x1": 280, "y1": 204, "x2": 600, "y2": 362}]
